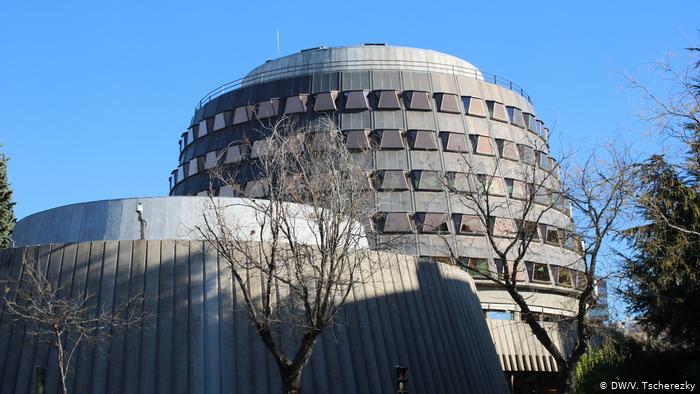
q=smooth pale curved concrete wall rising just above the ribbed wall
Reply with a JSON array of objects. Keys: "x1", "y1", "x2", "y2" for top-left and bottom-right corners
[{"x1": 12, "y1": 196, "x2": 340, "y2": 246}]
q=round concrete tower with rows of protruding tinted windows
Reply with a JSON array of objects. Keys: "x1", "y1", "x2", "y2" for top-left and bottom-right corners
[{"x1": 170, "y1": 44, "x2": 583, "y2": 385}]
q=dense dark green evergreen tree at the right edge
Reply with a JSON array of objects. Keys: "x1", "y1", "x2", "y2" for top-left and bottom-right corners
[{"x1": 624, "y1": 156, "x2": 700, "y2": 349}]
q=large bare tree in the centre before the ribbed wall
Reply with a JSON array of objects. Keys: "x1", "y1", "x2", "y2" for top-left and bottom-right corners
[{"x1": 197, "y1": 118, "x2": 374, "y2": 393}]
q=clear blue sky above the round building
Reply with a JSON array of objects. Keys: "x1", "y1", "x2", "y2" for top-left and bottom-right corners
[{"x1": 0, "y1": 0, "x2": 700, "y2": 218}]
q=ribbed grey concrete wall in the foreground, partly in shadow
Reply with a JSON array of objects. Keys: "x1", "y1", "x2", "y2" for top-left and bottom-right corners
[{"x1": 0, "y1": 241, "x2": 507, "y2": 393}]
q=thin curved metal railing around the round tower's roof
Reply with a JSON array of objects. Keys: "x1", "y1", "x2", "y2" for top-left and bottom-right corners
[{"x1": 195, "y1": 60, "x2": 532, "y2": 111}]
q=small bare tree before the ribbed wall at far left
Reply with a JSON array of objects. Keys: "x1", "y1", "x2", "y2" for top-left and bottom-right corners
[{"x1": 3, "y1": 251, "x2": 145, "y2": 394}]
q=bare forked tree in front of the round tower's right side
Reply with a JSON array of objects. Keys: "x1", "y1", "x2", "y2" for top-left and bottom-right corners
[{"x1": 444, "y1": 135, "x2": 634, "y2": 392}]
